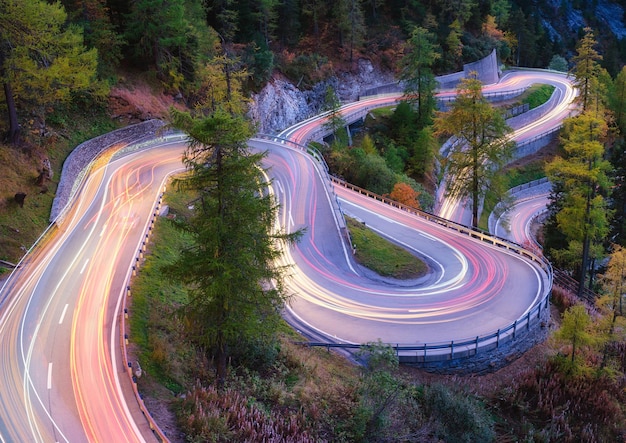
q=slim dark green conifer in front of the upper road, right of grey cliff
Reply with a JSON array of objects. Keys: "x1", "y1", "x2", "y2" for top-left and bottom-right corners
[{"x1": 400, "y1": 27, "x2": 441, "y2": 129}]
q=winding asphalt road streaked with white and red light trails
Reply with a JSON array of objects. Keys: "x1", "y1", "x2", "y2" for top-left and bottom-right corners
[{"x1": 0, "y1": 71, "x2": 573, "y2": 442}]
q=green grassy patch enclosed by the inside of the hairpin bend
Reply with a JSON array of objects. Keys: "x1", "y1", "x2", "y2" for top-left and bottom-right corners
[{"x1": 346, "y1": 217, "x2": 428, "y2": 279}]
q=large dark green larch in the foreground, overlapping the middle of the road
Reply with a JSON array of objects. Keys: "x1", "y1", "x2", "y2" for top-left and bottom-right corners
[{"x1": 166, "y1": 109, "x2": 300, "y2": 384}]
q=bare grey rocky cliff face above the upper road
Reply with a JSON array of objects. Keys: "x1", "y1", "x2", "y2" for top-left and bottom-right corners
[{"x1": 249, "y1": 60, "x2": 394, "y2": 134}]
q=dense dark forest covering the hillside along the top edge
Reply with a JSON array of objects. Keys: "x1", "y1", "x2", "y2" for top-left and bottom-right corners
[{"x1": 0, "y1": 0, "x2": 625, "y2": 147}]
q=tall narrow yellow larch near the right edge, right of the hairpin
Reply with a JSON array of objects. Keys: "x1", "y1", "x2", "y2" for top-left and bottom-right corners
[{"x1": 546, "y1": 28, "x2": 611, "y2": 295}]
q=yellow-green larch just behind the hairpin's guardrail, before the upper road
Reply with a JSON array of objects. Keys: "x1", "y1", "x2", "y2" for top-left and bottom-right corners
[{"x1": 434, "y1": 73, "x2": 512, "y2": 226}]
